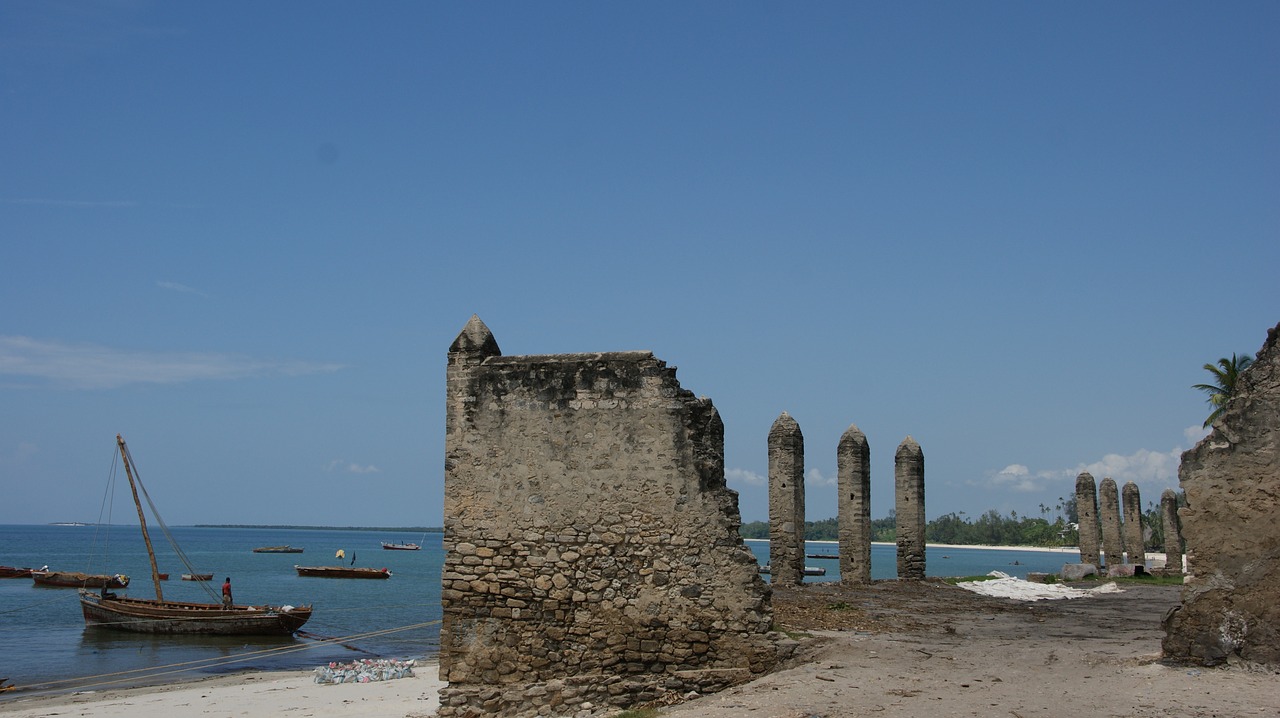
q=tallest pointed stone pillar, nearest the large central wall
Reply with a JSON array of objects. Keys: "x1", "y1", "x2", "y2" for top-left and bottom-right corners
[{"x1": 769, "y1": 412, "x2": 804, "y2": 586}]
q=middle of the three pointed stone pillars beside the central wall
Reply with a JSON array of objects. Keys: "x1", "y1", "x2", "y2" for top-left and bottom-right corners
[{"x1": 836, "y1": 425, "x2": 872, "y2": 584}]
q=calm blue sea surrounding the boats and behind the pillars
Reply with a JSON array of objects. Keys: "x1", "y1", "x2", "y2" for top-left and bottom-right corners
[{"x1": 0, "y1": 526, "x2": 1079, "y2": 701}]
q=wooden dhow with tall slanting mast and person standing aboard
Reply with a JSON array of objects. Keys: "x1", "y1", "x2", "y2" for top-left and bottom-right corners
[{"x1": 79, "y1": 435, "x2": 311, "y2": 636}]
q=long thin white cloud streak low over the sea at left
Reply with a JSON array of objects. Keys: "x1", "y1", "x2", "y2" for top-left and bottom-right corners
[{"x1": 0, "y1": 335, "x2": 342, "y2": 389}]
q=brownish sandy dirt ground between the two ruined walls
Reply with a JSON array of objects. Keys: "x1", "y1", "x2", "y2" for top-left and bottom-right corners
[{"x1": 660, "y1": 581, "x2": 1280, "y2": 718}]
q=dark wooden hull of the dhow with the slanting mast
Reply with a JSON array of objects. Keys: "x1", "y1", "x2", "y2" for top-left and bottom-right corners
[{"x1": 81, "y1": 591, "x2": 311, "y2": 636}]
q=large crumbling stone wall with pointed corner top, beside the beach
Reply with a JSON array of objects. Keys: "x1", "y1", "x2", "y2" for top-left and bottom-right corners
[{"x1": 439, "y1": 316, "x2": 778, "y2": 717}]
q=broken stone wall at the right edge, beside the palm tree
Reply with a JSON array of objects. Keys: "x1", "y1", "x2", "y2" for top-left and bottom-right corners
[{"x1": 1164, "y1": 325, "x2": 1280, "y2": 668}]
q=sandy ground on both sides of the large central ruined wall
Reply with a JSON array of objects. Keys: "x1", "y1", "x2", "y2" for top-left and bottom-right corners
[{"x1": 0, "y1": 581, "x2": 1280, "y2": 718}]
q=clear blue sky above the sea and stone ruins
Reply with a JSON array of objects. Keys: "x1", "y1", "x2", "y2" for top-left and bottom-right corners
[{"x1": 0, "y1": 1, "x2": 1280, "y2": 526}]
